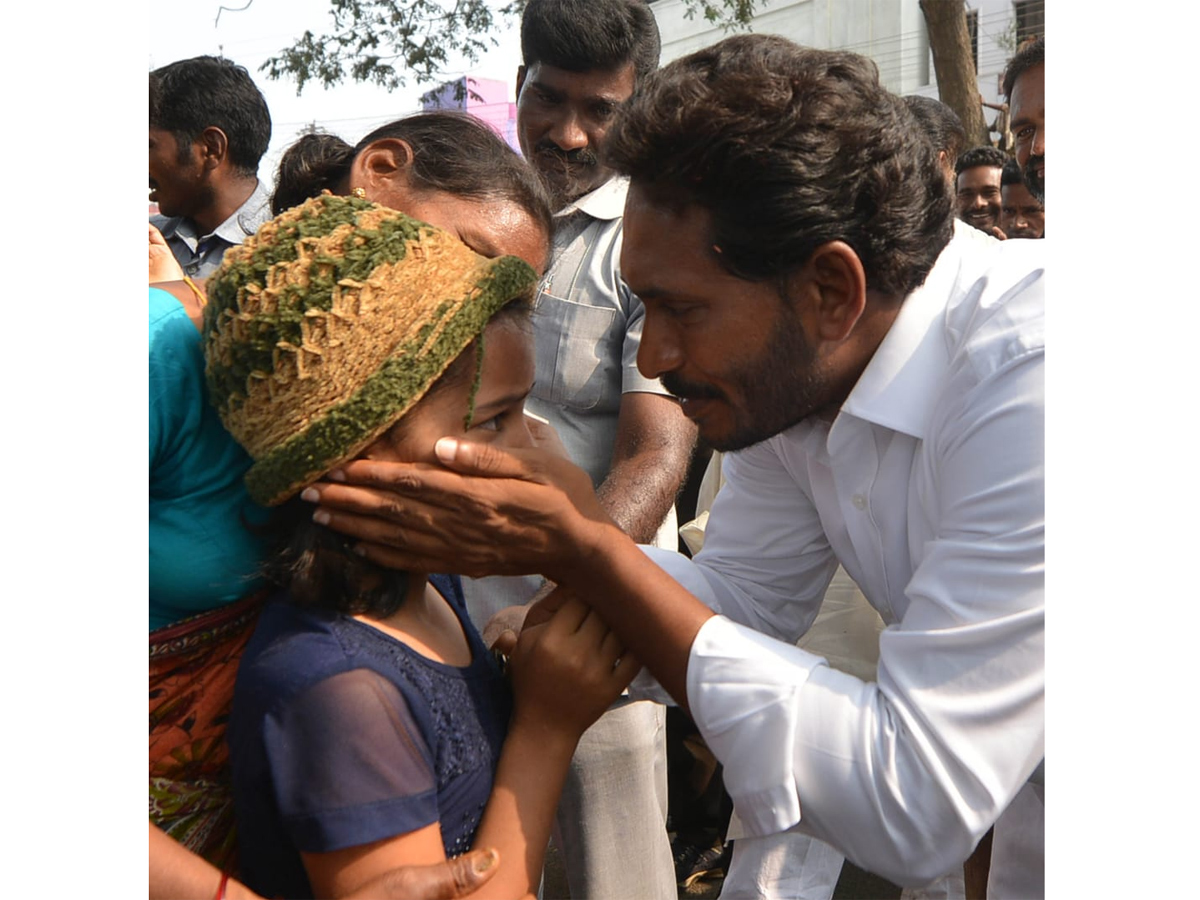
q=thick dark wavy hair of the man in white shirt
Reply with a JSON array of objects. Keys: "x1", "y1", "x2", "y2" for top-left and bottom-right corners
[{"x1": 605, "y1": 35, "x2": 953, "y2": 296}]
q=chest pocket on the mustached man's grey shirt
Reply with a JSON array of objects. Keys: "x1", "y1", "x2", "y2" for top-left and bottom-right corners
[{"x1": 534, "y1": 292, "x2": 623, "y2": 409}]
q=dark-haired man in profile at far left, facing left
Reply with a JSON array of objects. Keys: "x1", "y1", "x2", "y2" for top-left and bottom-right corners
[{"x1": 150, "y1": 56, "x2": 271, "y2": 278}]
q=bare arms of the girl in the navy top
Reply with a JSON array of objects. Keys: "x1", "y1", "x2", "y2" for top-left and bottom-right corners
[{"x1": 302, "y1": 600, "x2": 638, "y2": 898}]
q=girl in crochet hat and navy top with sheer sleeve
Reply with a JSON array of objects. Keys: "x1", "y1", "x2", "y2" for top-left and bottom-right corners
[{"x1": 204, "y1": 194, "x2": 636, "y2": 898}]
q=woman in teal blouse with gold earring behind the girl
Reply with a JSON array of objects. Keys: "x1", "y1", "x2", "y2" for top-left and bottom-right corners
[{"x1": 149, "y1": 112, "x2": 568, "y2": 898}]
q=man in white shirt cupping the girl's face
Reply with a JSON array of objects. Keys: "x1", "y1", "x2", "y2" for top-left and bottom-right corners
[{"x1": 304, "y1": 35, "x2": 1045, "y2": 898}]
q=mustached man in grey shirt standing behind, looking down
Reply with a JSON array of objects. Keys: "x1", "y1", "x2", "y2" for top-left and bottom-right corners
[{"x1": 464, "y1": 0, "x2": 696, "y2": 900}]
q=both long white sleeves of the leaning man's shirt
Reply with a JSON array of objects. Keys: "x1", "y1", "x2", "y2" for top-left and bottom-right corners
[{"x1": 655, "y1": 353, "x2": 1045, "y2": 883}]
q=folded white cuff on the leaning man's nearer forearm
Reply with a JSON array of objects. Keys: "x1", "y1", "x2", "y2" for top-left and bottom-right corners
[{"x1": 688, "y1": 616, "x2": 826, "y2": 838}]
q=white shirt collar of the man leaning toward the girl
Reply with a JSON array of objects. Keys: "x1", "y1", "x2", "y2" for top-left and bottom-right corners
[{"x1": 829, "y1": 221, "x2": 974, "y2": 449}]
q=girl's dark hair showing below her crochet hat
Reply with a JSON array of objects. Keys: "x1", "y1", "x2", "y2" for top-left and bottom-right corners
[{"x1": 262, "y1": 296, "x2": 532, "y2": 618}]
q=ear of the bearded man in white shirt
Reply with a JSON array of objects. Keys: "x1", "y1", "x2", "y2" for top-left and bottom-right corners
[{"x1": 793, "y1": 241, "x2": 866, "y2": 343}]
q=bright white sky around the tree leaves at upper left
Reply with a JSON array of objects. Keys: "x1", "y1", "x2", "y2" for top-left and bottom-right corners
[{"x1": 148, "y1": 0, "x2": 521, "y2": 187}]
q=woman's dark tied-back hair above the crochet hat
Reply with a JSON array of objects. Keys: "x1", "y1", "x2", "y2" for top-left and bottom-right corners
[{"x1": 271, "y1": 110, "x2": 553, "y2": 247}]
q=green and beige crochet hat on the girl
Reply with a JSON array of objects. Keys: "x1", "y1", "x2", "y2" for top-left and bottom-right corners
[{"x1": 204, "y1": 193, "x2": 536, "y2": 505}]
